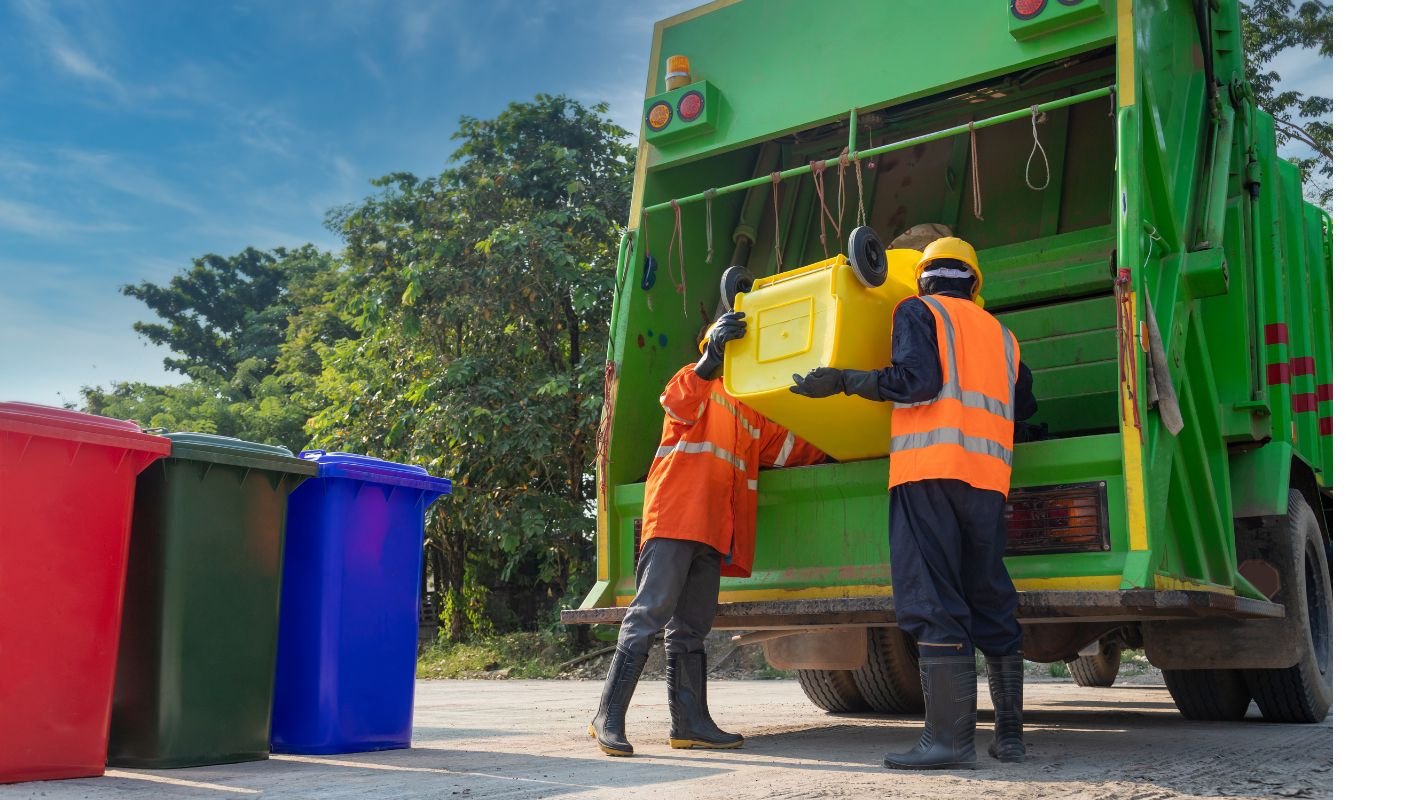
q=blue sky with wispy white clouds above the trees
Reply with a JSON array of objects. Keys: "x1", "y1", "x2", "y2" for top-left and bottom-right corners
[{"x1": 0, "y1": 0, "x2": 1332, "y2": 404}]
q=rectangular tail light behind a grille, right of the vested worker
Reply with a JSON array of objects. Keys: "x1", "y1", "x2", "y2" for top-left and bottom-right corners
[{"x1": 1007, "y1": 482, "x2": 1111, "y2": 556}]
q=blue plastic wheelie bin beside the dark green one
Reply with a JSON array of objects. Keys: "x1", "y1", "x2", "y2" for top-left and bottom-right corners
[{"x1": 272, "y1": 450, "x2": 451, "y2": 755}]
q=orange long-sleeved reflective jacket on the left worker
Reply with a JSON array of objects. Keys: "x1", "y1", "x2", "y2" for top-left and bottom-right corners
[{"x1": 641, "y1": 364, "x2": 826, "y2": 578}]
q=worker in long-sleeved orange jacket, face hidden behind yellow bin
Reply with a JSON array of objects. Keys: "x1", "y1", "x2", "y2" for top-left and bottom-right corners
[{"x1": 589, "y1": 311, "x2": 826, "y2": 756}]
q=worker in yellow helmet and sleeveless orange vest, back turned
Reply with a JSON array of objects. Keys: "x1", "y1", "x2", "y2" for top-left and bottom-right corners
[{"x1": 791, "y1": 237, "x2": 1037, "y2": 769}]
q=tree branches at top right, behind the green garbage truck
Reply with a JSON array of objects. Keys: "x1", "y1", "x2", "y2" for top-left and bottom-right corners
[{"x1": 1241, "y1": 0, "x2": 1332, "y2": 205}]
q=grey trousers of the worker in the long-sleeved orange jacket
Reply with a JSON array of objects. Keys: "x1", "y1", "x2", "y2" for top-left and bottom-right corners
[{"x1": 617, "y1": 539, "x2": 721, "y2": 654}]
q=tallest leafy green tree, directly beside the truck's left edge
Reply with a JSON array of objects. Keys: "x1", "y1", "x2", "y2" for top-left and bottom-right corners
[{"x1": 310, "y1": 95, "x2": 634, "y2": 638}]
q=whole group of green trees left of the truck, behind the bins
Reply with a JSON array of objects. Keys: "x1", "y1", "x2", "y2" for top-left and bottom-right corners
[{"x1": 84, "y1": 95, "x2": 634, "y2": 639}]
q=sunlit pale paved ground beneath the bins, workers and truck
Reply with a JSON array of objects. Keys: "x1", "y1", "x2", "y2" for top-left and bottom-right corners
[{"x1": 0, "y1": 681, "x2": 1332, "y2": 800}]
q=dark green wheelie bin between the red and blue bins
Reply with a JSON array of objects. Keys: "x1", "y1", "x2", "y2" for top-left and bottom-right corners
[{"x1": 108, "y1": 433, "x2": 317, "y2": 767}]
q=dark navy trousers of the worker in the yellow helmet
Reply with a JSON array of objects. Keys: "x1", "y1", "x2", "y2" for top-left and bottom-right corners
[{"x1": 889, "y1": 479, "x2": 1022, "y2": 656}]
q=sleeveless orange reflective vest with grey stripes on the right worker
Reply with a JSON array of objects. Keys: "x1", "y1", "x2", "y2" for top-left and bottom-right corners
[{"x1": 889, "y1": 294, "x2": 1020, "y2": 496}]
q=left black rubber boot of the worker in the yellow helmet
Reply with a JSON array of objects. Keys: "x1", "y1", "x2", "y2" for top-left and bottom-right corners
[{"x1": 884, "y1": 655, "x2": 977, "y2": 769}]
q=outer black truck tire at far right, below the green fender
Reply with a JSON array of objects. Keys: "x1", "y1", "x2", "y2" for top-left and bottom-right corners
[{"x1": 1241, "y1": 489, "x2": 1332, "y2": 722}]
